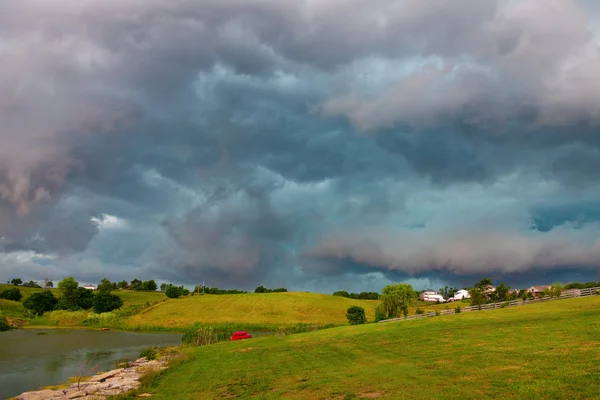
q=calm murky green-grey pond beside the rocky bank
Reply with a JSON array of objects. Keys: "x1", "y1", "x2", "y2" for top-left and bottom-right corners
[{"x1": 0, "y1": 329, "x2": 181, "y2": 399}]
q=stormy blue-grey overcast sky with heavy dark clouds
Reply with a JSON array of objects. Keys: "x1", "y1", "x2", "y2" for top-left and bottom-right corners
[{"x1": 0, "y1": 0, "x2": 600, "y2": 292}]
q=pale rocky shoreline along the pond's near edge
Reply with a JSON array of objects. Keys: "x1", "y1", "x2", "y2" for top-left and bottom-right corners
[{"x1": 15, "y1": 357, "x2": 168, "y2": 400}]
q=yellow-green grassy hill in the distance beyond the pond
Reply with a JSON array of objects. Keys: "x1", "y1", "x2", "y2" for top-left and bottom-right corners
[{"x1": 128, "y1": 292, "x2": 379, "y2": 326}]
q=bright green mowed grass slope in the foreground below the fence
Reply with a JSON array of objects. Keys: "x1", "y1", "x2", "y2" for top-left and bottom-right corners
[{"x1": 134, "y1": 296, "x2": 600, "y2": 400}]
